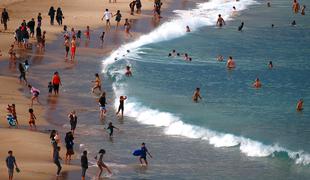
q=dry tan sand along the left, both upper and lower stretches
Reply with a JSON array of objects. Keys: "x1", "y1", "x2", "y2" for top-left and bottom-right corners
[{"x1": 0, "y1": 0, "x2": 168, "y2": 180}]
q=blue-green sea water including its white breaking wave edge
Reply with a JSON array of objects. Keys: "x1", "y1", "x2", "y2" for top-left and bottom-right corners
[{"x1": 102, "y1": 0, "x2": 310, "y2": 179}]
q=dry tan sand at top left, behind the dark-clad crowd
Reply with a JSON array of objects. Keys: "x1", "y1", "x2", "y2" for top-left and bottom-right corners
[{"x1": 0, "y1": 0, "x2": 154, "y2": 59}]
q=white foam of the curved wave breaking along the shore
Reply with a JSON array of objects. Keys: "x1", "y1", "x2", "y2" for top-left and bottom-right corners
[{"x1": 103, "y1": 0, "x2": 310, "y2": 165}]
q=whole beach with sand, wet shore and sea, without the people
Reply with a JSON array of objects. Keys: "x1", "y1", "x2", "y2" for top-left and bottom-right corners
[{"x1": 0, "y1": 0, "x2": 310, "y2": 180}]
